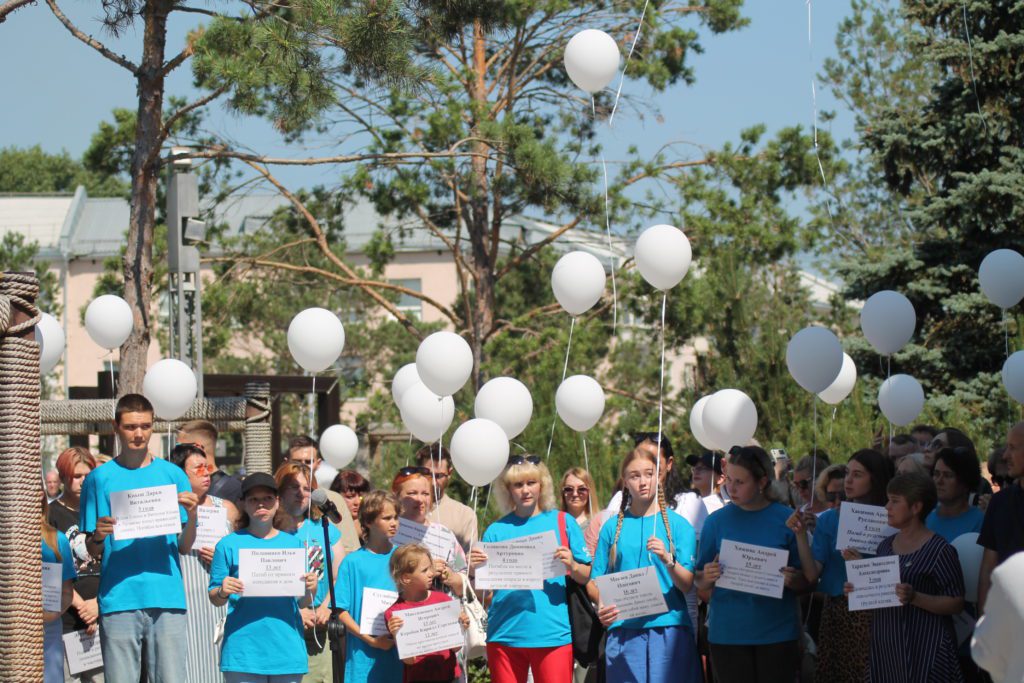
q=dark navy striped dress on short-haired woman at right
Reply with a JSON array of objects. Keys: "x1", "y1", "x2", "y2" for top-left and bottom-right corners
[{"x1": 866, "y1": 533, "x2": 964, "y2": 683}]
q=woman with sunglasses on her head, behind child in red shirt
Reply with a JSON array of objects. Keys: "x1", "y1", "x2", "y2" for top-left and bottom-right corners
[{"x1": 391, "y1": 466, "x2": 469, "y2": 595}]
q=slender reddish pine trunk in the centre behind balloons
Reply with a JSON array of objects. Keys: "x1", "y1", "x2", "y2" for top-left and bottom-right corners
[{"x1": 467, "y1": 19, "x2": 498, "y2": 389}]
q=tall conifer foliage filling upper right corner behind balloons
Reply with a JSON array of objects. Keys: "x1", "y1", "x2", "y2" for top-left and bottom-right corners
[{"x1": 826, "y1": 0, "x2": 1024, "y2": 445}]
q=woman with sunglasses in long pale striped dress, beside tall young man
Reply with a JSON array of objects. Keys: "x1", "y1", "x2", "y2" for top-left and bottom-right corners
[{"x1": 170, "y1": 443, "x2": 239, "y2": 681}]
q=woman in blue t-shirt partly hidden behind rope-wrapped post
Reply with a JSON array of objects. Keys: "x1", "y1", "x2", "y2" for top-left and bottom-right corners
[{"x1": 41, "y1": 492, "x2": 78, "y2": 683}]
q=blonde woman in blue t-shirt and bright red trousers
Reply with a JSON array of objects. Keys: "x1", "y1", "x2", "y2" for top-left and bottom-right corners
[{"x1": 469, "y1": 456, "x2": 590, "y2": 683}]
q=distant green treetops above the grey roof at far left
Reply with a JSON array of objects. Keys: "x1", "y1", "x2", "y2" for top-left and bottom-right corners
[{"x1": 0, "y1": 144, "x2": 127, "y2": 197}]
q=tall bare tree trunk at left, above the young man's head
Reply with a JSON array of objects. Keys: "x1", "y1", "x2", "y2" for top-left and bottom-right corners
[{"x1": 118, "y1": 0, "x2": 169, "y2": 396}]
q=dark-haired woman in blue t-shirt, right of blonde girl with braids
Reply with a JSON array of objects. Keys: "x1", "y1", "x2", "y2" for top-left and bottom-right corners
[{"x1": 697, "y1": 446, "x2": 809, "y2": 683}]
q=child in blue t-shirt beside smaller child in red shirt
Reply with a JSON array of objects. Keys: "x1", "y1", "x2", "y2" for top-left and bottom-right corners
[{"x1": 334, "y1": 490, "x2": 402, "y2": 683}]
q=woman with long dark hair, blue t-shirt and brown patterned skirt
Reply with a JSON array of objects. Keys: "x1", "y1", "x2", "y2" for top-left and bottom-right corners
[{"x1": 786, "y1": 449, "x2": 893, "y2": 683}]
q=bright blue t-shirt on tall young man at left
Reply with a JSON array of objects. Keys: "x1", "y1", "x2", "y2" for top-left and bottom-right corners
[{"x1": 79, "y1": 458, "x2": 191, "y2": 614}]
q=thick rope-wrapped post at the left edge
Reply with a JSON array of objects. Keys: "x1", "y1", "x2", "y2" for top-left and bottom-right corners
[{"x1": 0, "y1": 272, "x2": 43, "y2": 683}]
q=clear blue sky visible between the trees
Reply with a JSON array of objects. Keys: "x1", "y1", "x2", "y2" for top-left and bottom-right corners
[{"x1": 0, "y1": 0, "x2": 852, "y2": 193}]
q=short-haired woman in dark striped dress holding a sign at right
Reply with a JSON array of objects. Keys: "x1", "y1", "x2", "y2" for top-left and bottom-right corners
[{"x1": 845, "y1": 474, "x2": 964, "y2": 683}]
